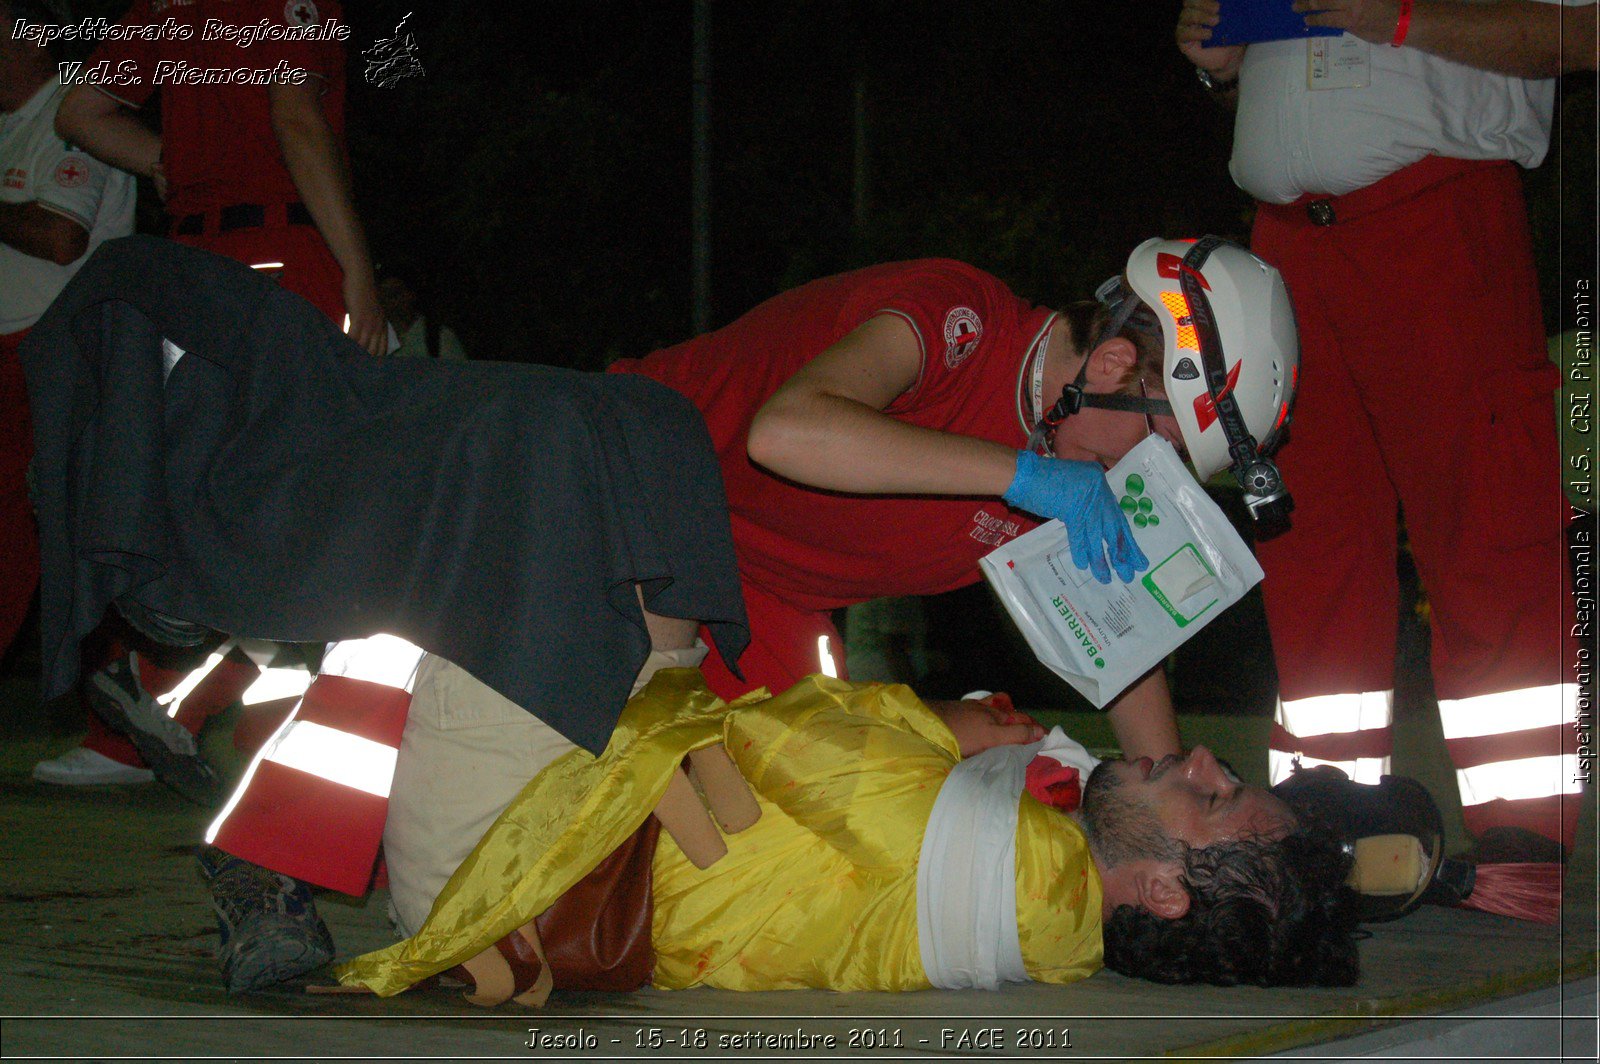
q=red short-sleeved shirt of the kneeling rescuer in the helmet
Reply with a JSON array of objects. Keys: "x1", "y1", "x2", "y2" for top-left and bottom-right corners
[{"x1": 611, "y1": 259, "x2": 1050, "y2": 614}]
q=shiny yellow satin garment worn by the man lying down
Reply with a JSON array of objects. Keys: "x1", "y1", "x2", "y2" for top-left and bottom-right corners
[{"x1": 339, "y1": 669, "x2": 1101, "y2": 995}]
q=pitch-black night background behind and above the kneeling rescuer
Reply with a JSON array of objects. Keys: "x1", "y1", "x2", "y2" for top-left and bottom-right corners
[{"x1": 50, "y1": 0, "x2": 1595, "y2": 712}]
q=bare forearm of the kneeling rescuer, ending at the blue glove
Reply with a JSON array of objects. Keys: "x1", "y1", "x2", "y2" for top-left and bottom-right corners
[{"x1": 749, "y1": 394, "x2": 1016, "y2": 498}]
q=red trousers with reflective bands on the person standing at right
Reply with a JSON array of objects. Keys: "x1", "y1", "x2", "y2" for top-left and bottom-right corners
[{"x1": 1254, "y1": 158, "x2": 1581, "y2": 846}]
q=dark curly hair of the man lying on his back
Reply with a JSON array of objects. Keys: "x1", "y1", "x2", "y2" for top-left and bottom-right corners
[{"x1": 1104, "y1": 808, "x2": 1360, "y2": 987}]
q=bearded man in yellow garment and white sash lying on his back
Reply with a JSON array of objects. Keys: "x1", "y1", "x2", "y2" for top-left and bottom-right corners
[{"x1": 339, "y1": 669, "x2": 1357, "y2": 1003}]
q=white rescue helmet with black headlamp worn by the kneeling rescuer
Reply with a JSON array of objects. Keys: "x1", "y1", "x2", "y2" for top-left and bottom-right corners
[{"x1": 1126, "y1": 237, "x2": 1299, "y2": 480}]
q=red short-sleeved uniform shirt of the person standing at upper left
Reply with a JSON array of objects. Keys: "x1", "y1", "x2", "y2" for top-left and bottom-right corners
[{"x1": 86, "y1": 0, "x2": 344, "y2": 218}]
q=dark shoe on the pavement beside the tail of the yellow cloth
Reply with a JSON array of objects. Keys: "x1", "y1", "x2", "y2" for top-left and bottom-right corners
[{"x1": 198, "y1": 846, "x2": 333, "y2": 994}]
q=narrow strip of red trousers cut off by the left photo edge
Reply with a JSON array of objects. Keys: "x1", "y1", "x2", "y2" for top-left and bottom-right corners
[{"x1": 0, "y1": 330, "x2": 38, "y2": 654}]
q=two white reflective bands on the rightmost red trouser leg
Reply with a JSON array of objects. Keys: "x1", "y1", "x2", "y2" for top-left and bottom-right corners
[{"x1": 1438, "y1": 683, "x2": 1582, "y2": 806}]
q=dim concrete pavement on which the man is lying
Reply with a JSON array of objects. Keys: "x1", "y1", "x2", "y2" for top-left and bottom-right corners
[{"x1": 0, "y1": 682, "x2": 1595, "y2": 1061}]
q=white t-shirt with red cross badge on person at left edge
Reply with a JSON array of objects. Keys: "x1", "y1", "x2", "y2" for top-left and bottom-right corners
[{"x1": 0, "y1": 78, "x2": 134, "y2": 333}]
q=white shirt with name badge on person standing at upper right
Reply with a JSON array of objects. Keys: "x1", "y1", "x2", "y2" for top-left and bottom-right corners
[{"x1": 1229, "y1": 0, "x2": 1590, "y2": 203}]
